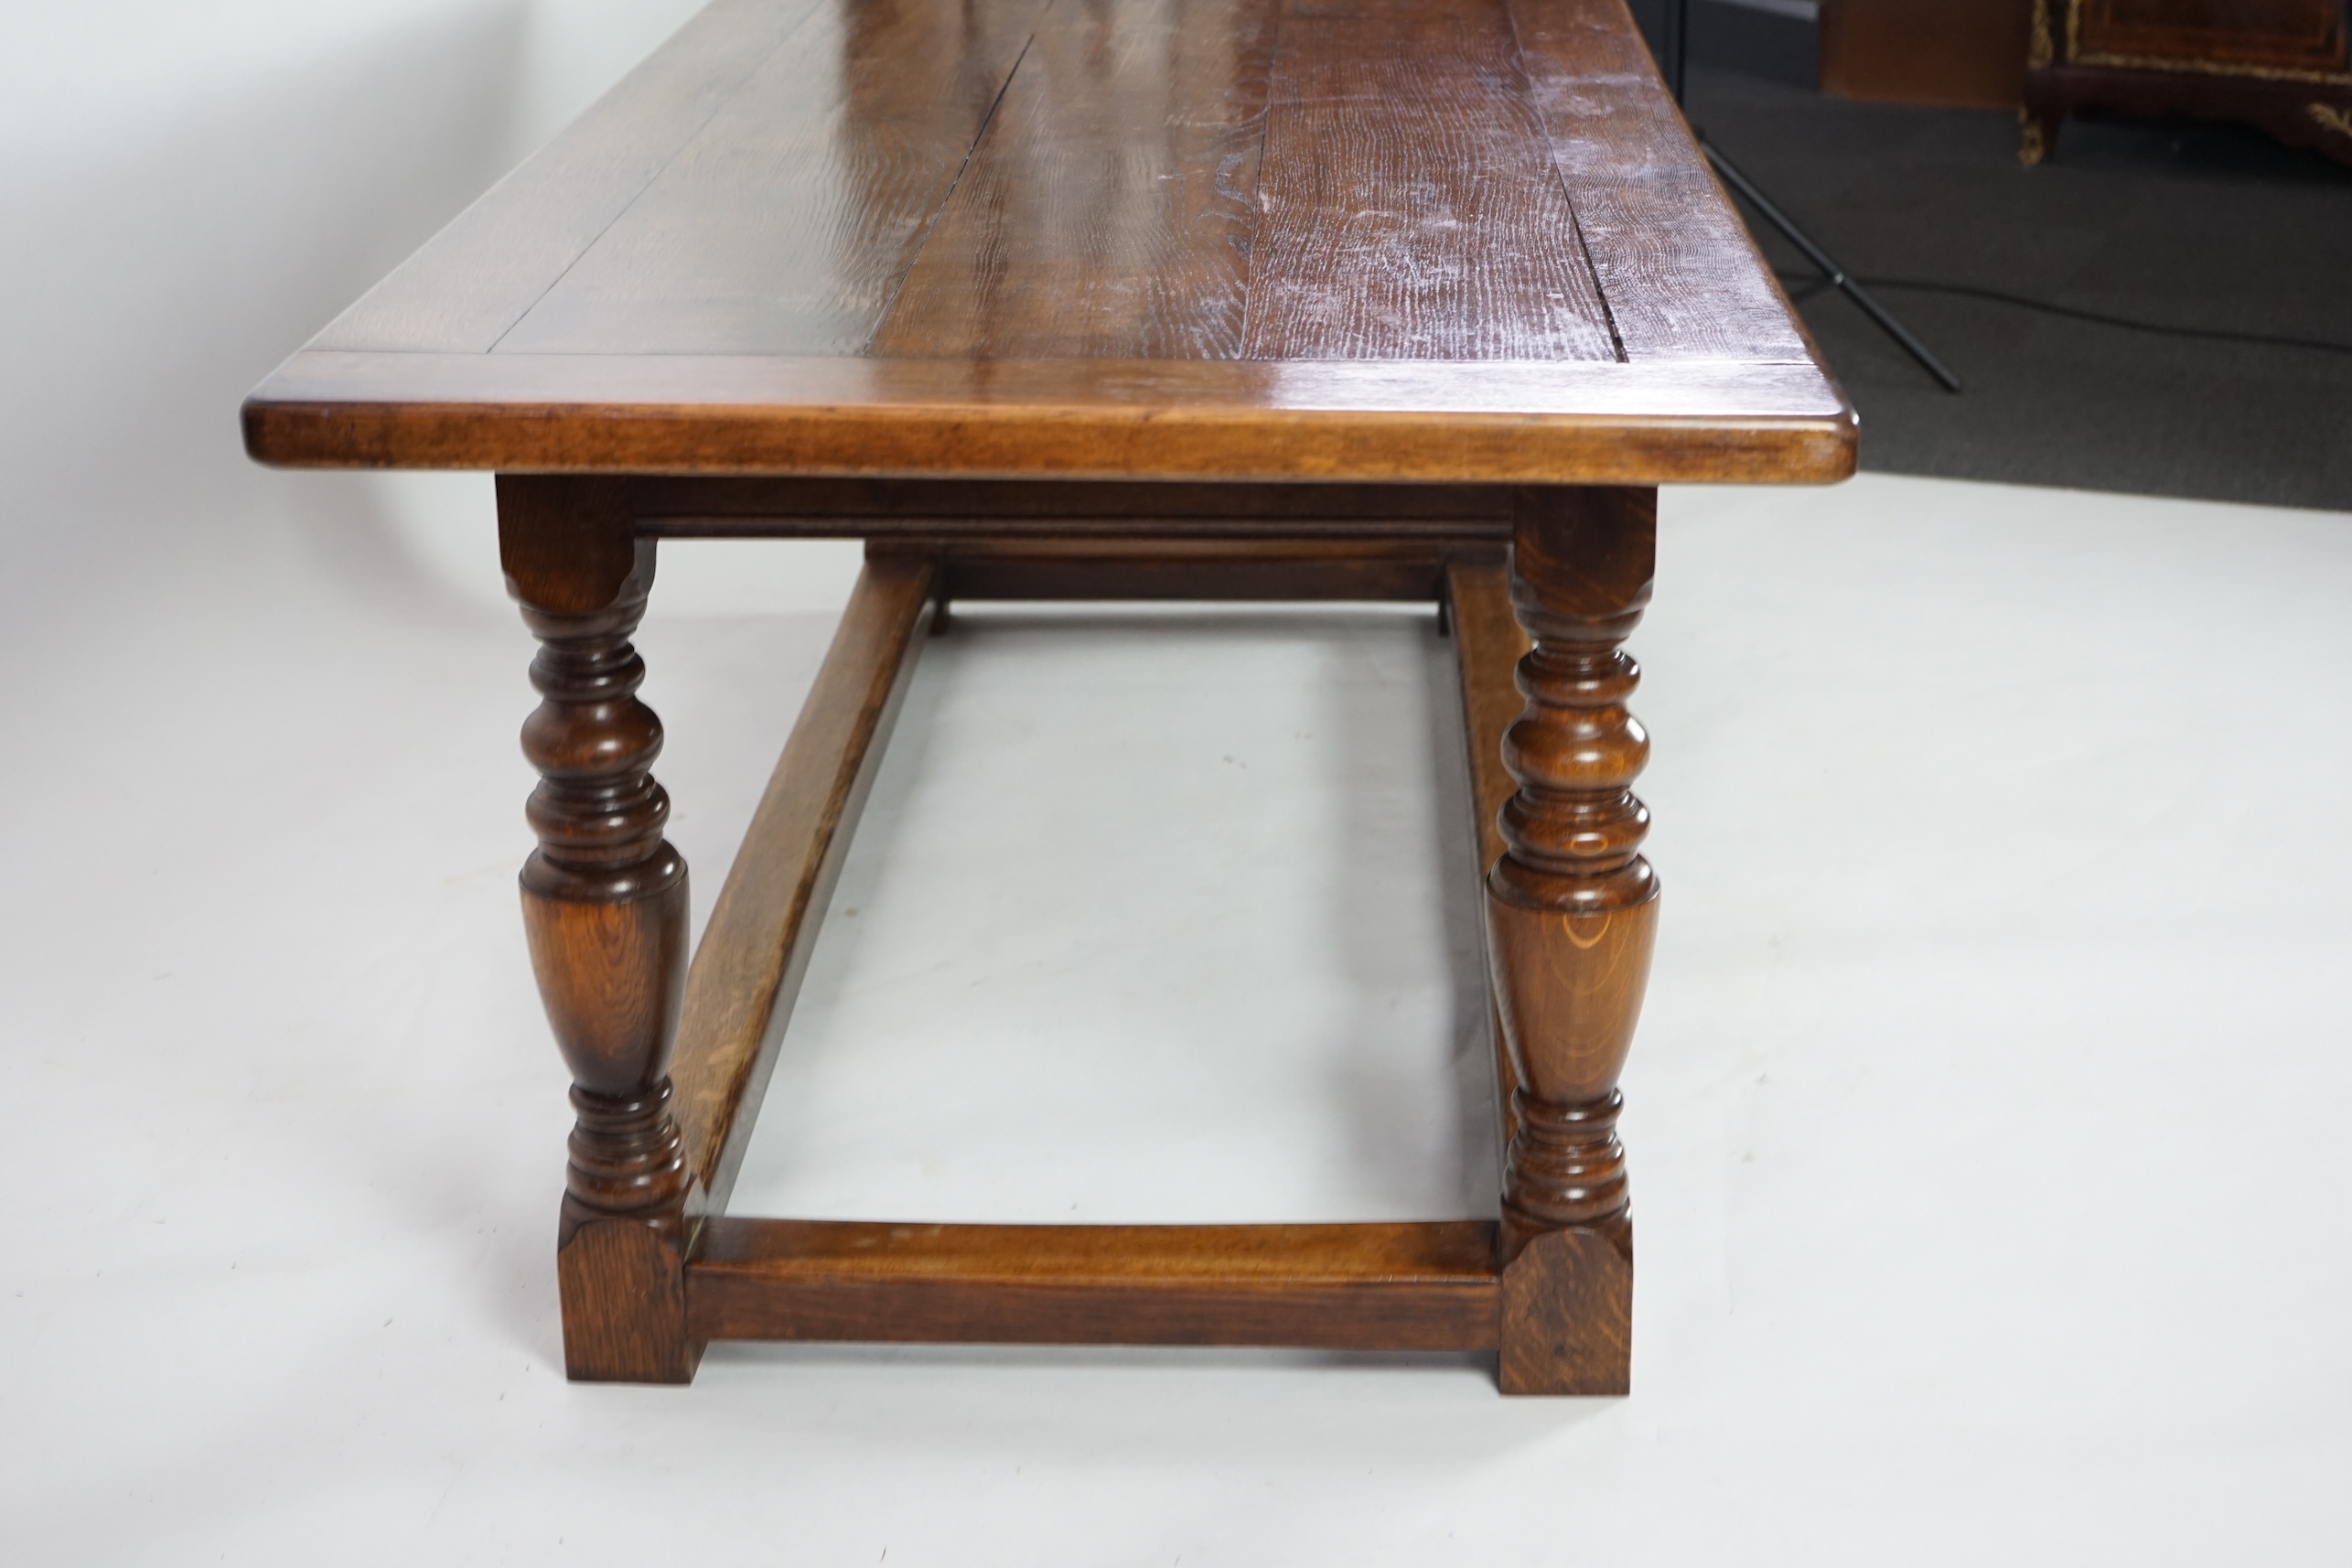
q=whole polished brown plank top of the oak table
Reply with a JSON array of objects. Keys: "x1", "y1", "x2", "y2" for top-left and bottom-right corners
[{"x1": 244, "y1": 0, "x2": 1856, "y2": 484}]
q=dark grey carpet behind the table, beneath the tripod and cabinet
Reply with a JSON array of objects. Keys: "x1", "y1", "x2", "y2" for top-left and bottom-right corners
[{"x1": 1689, "y1": 63, "x2": 2352, "y2": 510}]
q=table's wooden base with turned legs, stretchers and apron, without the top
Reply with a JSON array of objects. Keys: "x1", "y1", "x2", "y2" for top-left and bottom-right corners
[{"x1": 499, "y1": 475, "x2": 1656, "y2": 1394}]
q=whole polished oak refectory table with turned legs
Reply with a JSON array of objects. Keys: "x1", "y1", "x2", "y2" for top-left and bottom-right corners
[{"x1": 244, "y1": 0, "x2": 1856, "y2": 1394}]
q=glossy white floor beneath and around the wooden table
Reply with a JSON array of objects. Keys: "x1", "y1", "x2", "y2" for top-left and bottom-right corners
[{"x1": 0, "y1": 475, "x2": 2352, "y2": 1568}]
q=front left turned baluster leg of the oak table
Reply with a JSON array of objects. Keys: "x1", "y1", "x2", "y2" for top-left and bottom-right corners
[{"x1": 499, "y1": 475, "x2": 699, "y2": 1382}]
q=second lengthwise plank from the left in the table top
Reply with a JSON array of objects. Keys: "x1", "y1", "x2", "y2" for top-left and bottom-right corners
[{"x1": 499, "y1": 0, "x2": 1047, "y2": 355}]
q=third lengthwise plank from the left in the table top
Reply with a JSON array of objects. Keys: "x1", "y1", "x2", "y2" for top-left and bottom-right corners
[{"x1": 873, "y1": 0, "x2": 1274, "y2": 360}]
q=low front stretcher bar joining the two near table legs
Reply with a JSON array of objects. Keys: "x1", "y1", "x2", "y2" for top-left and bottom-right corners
[{"x1": 687, "y1": 1220, "x2": 1498, "y2": 1349}]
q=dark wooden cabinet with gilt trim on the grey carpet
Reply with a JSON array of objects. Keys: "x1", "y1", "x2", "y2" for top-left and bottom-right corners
[{"x1": 2018, "y1": 0, "x2": 2352, "y2": 162}]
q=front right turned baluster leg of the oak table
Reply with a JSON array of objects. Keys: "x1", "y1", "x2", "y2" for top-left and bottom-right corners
[{"x1": 1487, "y1": 489, "x2": 1659, "y2": 1394}]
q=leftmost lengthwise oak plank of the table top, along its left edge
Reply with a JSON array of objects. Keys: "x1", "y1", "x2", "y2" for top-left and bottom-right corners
[{"x1": 316, "y1": 0, "x2": 825, "y2": 352}]
